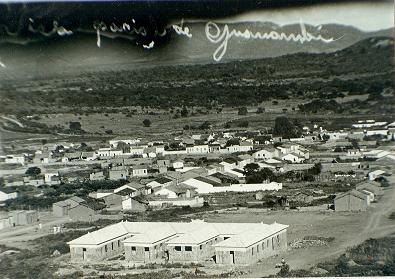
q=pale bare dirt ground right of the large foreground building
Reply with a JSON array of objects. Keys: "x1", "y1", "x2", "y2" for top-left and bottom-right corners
[{"x1": 204, "y1": 173, "x2": 395, "y2": 277}]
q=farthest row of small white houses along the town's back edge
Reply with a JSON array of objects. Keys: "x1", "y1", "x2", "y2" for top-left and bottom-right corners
[{"x1": 4, "y1": 120, "x2": 395, "y2": 164}]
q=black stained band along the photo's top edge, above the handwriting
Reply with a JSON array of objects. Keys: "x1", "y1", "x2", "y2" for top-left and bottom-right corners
[{"x1": 0, "y1": 0, "x2": 390, "y2": 40}]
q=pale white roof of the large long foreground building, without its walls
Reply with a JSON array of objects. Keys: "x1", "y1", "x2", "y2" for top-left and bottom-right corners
[{"x1": 68, "y1": 220, "x2": 288, "y2": 247}]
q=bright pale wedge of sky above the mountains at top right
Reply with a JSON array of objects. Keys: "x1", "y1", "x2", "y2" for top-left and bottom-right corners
[{"x1": 215, "y1": 1, "x2": 394, "y2": 32}]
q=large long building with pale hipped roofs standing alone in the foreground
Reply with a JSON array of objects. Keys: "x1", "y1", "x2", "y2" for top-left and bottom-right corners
[{"x1": 68, "y1": 220, "x2": 288, "y2": 264}]
